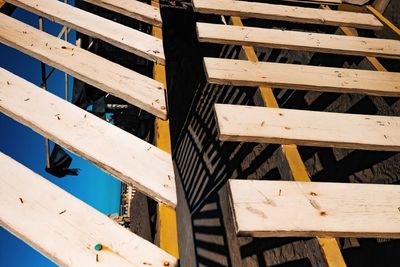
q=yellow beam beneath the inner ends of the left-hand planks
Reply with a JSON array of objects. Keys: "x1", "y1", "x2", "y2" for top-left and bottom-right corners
[{"x1": 151, "y1": 1, "x2": 179, "y2": 258}]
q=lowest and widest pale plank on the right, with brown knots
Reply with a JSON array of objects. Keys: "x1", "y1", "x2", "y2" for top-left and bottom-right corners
[{"x1": 229, "y1": 180, "x2": 400, "y2": 238}]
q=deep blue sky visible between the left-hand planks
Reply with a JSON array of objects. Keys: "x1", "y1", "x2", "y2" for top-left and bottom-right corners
[{"x1": 0, "y1": 4, "x2": 121, "y2": 267}]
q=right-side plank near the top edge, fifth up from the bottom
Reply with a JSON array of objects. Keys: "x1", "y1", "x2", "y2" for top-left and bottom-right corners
[{"x1": 193, "y1": 0, "x2": 383, "y2": 30}]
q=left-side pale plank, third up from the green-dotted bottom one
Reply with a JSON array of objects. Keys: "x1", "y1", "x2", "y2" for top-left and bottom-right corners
[{"x1": 0, "y1": 14, "x2": 167, "y2": 119}]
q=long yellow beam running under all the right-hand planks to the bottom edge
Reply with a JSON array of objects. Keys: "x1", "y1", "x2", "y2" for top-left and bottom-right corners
[{"x1": 231, "y1": 16, "x2": 346, "y2": 267}]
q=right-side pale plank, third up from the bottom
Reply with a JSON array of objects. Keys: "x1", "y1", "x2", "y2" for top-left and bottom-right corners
[{"x1": 204, "y1": 58, "x2": 400, "y2": 96}]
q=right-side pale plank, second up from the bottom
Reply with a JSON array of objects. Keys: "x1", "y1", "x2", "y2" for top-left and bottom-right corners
[{"x1": 215, "y1": 104, "x2": 400, "y2": 151}]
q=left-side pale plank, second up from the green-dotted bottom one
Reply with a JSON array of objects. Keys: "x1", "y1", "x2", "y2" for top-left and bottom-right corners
[{"x1": 0, "y1": 68, "x2": 176, "y2": 207}]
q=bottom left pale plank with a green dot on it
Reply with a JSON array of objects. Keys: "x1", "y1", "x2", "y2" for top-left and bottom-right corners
[{"x1": 0, "y1": 153, "x2": 177, "y2": 267}]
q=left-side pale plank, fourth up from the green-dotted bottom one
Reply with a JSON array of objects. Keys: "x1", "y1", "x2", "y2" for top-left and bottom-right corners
[{"x1": 6, "y1": 0, "x2": 165, "y2": 64}]
